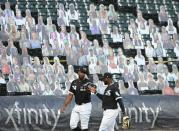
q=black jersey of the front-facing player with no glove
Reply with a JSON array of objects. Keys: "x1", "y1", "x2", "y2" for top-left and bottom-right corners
[{"x1": 69, "y1": 79, "x2": 92, "y2": 105}]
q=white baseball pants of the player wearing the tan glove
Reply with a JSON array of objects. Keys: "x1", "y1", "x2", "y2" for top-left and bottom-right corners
[{"x1": 99, "y1": 109, "x2": 119, "y2": 131}]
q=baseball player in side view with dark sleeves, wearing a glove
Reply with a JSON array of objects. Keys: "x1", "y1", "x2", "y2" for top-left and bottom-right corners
[{"x1": 90, "y1": 73, "x2": 125, "y2": 131}]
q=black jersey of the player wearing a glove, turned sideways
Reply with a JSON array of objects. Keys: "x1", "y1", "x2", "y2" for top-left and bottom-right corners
[{"x1": 102, "y1": 83, "x2": 122, "y2": 110}]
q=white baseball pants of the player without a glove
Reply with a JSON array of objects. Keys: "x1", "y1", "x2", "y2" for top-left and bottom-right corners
[{"x1": 70, "y1": 102, "x2": 92, "y2": 130}]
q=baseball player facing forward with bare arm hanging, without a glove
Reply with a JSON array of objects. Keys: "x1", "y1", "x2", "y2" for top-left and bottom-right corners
[{"x1": 60, "y1": 67, "x2": 94, "y2": 131}]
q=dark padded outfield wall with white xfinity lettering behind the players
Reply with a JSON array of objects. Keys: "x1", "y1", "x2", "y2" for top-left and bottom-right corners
[{"x1": 0, "y1": 96, "x2": 179, "y2": 131}]
